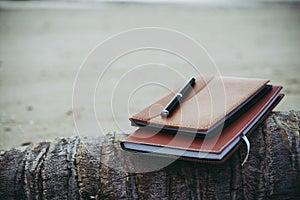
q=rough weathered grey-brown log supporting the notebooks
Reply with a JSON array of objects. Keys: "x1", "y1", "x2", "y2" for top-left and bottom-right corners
[{"x1": 0, "y1": 111, "x2": 300, "y2": 199}]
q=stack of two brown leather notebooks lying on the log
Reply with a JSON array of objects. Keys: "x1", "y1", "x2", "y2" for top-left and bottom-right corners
[{"x1": 121, "y1": 76, "x2": 284, "y2": 162}]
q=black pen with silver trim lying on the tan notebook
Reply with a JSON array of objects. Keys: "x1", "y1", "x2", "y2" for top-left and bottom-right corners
[{"x1": 160, "y1": 77, "x2": 196, "y2": 118}]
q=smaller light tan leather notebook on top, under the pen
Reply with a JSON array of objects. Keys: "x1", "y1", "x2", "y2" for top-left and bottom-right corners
[{"x1": 130, "y1": 76, "x2": 269, "y2": 135}]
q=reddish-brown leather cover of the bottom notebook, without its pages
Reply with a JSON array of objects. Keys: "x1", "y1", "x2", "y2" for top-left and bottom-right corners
[{"x1": 121, "y1": 86, "x2": 283, "y2": 161}]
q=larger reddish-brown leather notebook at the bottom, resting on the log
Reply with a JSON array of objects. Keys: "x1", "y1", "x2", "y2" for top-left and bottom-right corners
[{"x1": 121, "y1": 86, "x2": 284, "y2": 162}]
